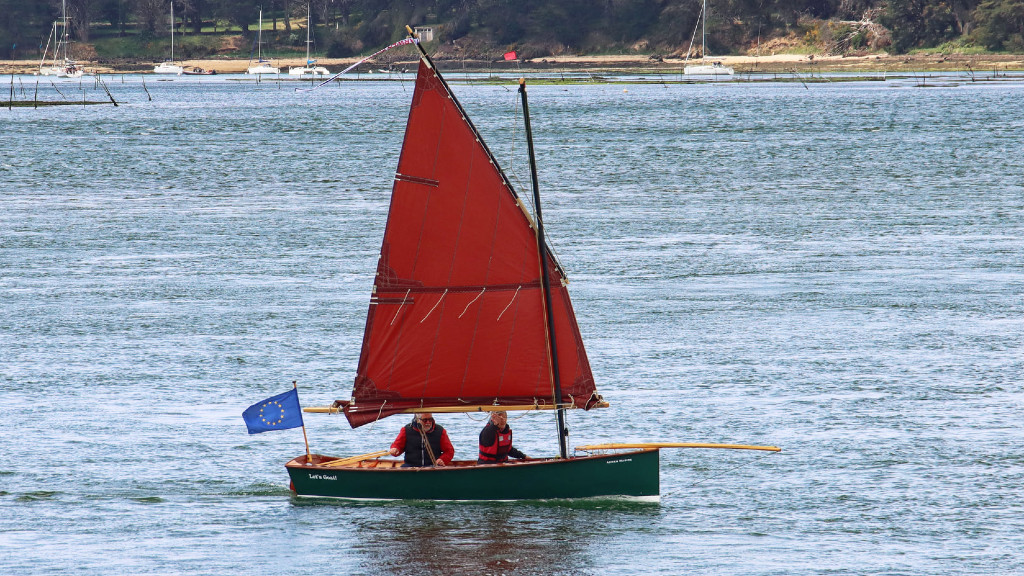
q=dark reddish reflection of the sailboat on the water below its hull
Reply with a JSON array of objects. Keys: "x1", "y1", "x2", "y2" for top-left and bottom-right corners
[{"x1": 293, "y1": 499, "x2": 662, "y2": 574}]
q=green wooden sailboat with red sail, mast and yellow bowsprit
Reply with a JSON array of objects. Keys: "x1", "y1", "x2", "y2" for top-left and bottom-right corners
[{"x1": 286, "y1": 31, "x2": 777, "y2": 500}]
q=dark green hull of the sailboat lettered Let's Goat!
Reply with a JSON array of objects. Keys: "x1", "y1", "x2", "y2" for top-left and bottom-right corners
[{"x1": 286, "y1": 449, "x2": 658, "y2": 500}]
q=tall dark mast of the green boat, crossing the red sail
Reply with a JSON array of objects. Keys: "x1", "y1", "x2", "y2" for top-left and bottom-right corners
[{"x1": 519, "y1": 79, "x2": 568, "y2": 458}]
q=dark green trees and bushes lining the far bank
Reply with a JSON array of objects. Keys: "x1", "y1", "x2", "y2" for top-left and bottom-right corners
[{"x1": 0, "y1": 0, "x2": 1024, "y2": 57}]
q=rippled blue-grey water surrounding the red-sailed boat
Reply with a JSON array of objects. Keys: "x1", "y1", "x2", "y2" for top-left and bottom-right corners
[{"x1": 0, "y1": 75, "x2": 1024, "y2": 576}]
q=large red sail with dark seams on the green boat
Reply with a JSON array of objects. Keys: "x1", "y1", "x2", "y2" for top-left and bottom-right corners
[{"x1": 345, "y1": 60, "x2": 598, "y2": 427}]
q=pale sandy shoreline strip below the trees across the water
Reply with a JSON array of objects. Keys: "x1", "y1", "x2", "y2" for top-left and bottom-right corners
[{"x1": 0, "y1": 53, "x2": 1024, "y2": 75}]
